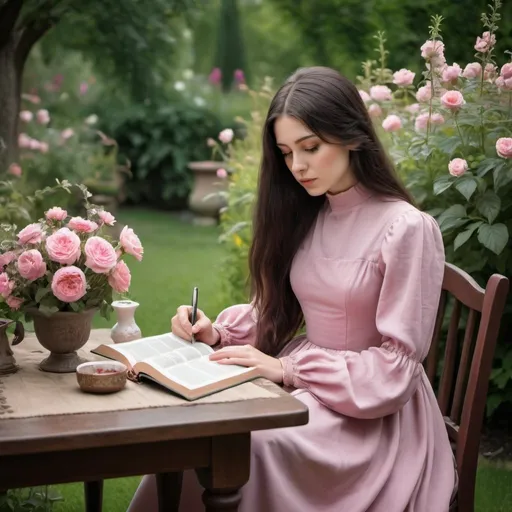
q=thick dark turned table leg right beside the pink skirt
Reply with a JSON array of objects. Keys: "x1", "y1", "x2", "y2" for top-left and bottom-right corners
[{"x1": 197, "y1": 433, "x2": 251, "y2": 512}]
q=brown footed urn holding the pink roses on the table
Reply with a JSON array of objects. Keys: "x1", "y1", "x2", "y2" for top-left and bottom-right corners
[{"x1": 27, "y1": 308, "x2": 97, "y2": 373}]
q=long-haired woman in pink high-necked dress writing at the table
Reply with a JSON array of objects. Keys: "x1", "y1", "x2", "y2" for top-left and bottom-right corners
[{"x1": 130, "y1": 67, "x2": 457, "y2": 512}]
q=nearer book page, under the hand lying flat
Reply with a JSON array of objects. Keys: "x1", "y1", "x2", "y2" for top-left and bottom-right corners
[{"x1": 148, "y1": 354, "x2": 253, "y2": 389}]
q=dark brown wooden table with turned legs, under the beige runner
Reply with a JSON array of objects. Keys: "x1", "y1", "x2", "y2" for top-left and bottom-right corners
[{"x1": 0, "y1": 374, "x2": 308, "y2": 512}]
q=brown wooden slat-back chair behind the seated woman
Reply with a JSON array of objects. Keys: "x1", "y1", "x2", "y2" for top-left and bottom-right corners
[{"x1": 425, "y1": 263, "x2": 509, "y2": 512}]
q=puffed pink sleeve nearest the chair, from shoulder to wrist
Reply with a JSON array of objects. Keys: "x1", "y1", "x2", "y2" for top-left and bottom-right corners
[{"x1": 281, "y1": 210, "x2": 445, "y2": 419}]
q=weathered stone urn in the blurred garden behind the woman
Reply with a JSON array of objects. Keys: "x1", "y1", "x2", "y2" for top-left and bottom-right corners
[{"x1": 188, "y1": 161, "x2": 228, "y2": 225}]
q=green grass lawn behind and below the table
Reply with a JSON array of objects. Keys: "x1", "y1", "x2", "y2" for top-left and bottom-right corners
[{"x1": 49, "y1": 210, "x2": 512, "y2": 512}]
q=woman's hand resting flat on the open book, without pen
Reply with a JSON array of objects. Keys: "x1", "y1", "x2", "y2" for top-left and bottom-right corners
[{"x1": 210, "y1": 345, "x2": 283, "y2": 384}]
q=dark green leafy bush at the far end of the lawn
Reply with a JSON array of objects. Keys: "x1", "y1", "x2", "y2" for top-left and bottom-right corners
[{"x1": 105, "y1": 103, "x2": 220, "y2": 209}]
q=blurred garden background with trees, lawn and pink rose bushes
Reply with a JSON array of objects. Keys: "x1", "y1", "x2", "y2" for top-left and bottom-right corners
[{"x1": 0, "y1": 0, "x2": 512, "y2": 512}]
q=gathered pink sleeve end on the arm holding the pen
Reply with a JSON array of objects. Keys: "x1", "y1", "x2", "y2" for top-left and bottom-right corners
[{"x1": 213, "y1": 304, "x2": 256, "y2": 347}]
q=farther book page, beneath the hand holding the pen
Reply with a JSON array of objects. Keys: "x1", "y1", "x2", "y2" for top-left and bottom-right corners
[{"x1": 112, "y1": 333, "x2": 213, "y2": 366}]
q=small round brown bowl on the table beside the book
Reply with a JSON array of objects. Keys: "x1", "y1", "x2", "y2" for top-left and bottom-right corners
[{"x1": 76, "y1": 361, "x2": 128, "y2": 393}]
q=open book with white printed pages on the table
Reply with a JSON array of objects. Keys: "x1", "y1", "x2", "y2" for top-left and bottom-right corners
[{"x1": 91, "y1": 333, "x2": 259, "y2": 400}]
